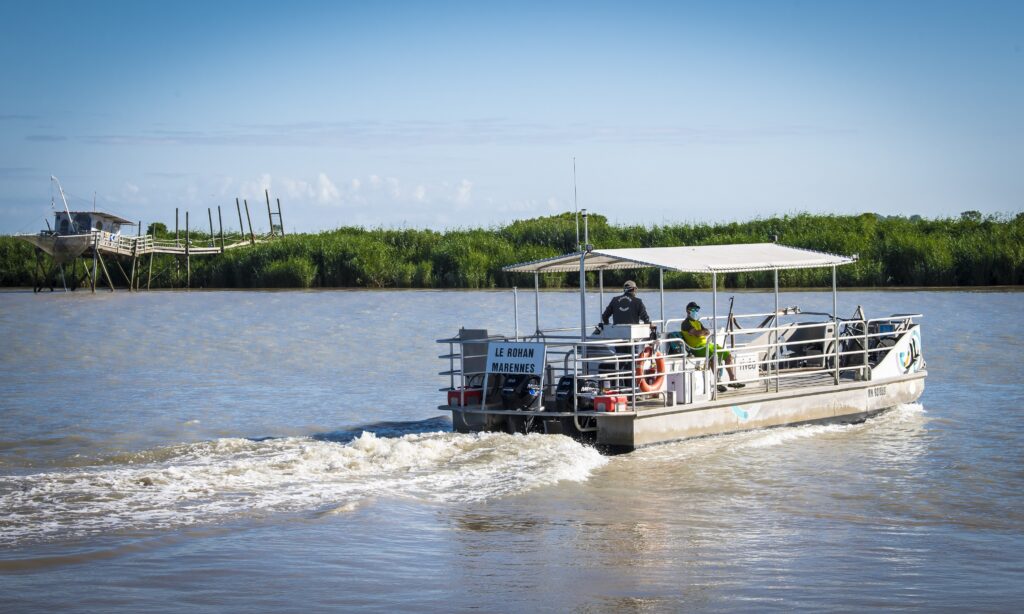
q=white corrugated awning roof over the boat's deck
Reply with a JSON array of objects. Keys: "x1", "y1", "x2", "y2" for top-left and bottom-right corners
[{"x1": 502, "y1": 244, "x2": 856, "y2": 273}]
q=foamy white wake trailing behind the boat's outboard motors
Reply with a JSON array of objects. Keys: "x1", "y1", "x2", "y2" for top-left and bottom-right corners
[{"x1": 0, "y1": 423, "x2": 606, "y2": 546}]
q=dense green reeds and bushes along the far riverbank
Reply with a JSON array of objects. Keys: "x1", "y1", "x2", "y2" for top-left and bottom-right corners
[{"x1": 0, "y1": 211, "x2": 1024, "y2": 289}]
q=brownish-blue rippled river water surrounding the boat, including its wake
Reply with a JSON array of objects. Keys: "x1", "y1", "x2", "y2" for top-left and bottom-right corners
[{"x1": 0, "y1": 292, "x2": 1024, "y2": 612}]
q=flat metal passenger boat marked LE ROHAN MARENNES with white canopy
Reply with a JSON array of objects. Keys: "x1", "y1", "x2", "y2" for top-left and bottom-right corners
[{"x1": 437, "y1": 243, "x2": 928, "y2": 452}]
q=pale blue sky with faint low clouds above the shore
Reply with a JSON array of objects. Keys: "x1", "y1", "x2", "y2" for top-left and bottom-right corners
[{"x1": 0, "y1": 0, "x2": 1024, "y2": 233}]
